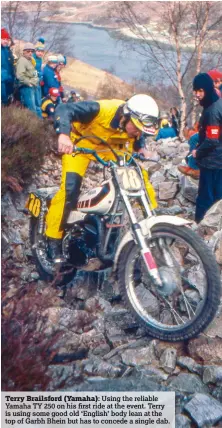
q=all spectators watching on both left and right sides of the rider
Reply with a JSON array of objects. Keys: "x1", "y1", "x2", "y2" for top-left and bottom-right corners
[{"x1": 1, "y1": 28, "x2": 222, "y2": 222}]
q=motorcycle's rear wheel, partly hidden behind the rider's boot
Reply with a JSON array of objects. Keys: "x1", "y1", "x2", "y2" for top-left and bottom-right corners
[{"x1": 29, "y1": 217, "x2": 77, "y2": 287}]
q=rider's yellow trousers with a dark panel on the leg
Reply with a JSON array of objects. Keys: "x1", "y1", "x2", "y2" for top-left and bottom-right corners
[{"x1": 46, "y1": 142, "x2": 119, "y2": 239}]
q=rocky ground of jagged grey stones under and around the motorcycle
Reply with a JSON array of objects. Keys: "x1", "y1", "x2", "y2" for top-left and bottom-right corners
[{"x1": 2, "y1": 139, "x2": 222, "y2": 428}]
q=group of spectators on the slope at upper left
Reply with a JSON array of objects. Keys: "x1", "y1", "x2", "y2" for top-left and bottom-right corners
[{"x1": 1, "y1": 28, "x2": 81, "y2": 120}]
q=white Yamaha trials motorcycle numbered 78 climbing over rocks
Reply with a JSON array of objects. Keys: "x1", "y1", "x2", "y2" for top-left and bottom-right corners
[{"x1": 27, "y1": 136, "x2": 220, "y2": 342}]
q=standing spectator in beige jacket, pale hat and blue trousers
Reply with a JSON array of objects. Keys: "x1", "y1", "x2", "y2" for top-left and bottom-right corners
[{"x1": 16, "y1": 43, "x2": 42, "y2": 117}]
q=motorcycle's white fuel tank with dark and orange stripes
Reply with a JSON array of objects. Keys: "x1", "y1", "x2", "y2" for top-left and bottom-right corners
[{"x1": 77, "y1": 180, "x2": 116, "y2": 215}]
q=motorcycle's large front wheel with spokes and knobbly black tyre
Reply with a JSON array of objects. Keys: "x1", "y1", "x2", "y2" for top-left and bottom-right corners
[{"x1": 117, "y1": 224, "x2": 221, "y2": 342}]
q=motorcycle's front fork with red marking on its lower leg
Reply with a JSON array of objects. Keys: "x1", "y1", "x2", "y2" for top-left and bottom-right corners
[{"x1": 120, "y1": 189, "x2": 162, "y2": 287}]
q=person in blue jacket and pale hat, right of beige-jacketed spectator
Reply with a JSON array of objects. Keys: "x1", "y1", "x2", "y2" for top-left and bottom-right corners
[{"x1": 43, "y1": 55, "x2": 60, "y2": 97}]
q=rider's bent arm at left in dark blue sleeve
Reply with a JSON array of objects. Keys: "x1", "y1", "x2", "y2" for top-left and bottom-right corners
[{"x1": 54, "y1": 101, "x2": 100, "y2": 135}]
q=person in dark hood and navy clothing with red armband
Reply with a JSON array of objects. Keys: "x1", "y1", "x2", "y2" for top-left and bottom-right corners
[{"x1": 192, "y1": 73, "x2": 222, "y2": 223}]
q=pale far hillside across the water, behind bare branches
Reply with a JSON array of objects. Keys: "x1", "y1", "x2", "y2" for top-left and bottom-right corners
[{"x1": 41, "y1": 1, "x2": 222, "y2": 51}]
